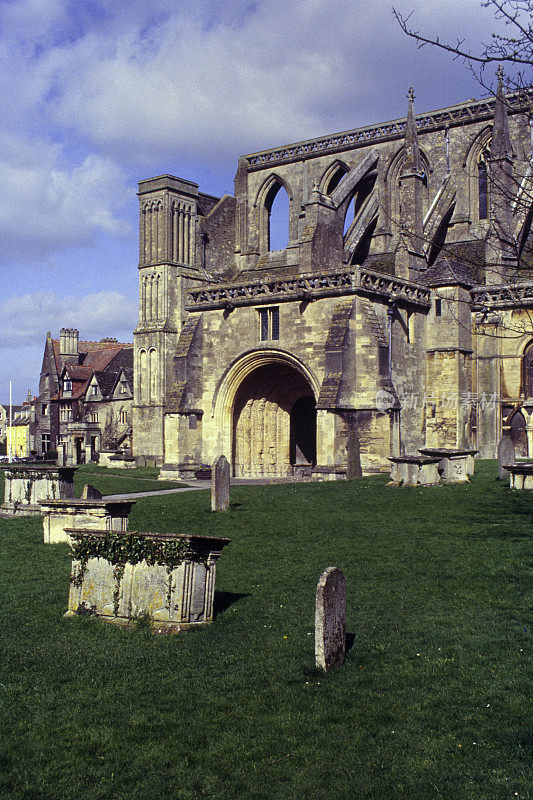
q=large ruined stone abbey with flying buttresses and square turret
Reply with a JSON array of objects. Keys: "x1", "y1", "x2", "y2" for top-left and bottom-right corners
[{"x1": 133, "y1": 78, "x2": 533, "y2": 478}]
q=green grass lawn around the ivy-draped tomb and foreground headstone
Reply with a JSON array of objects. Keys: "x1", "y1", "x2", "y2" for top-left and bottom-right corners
[{"x1": 0, "y1": 462, "x2": 533, "y2": 800}]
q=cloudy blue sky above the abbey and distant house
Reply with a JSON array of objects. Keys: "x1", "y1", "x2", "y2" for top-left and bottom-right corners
[{"x1": 0, "y1": 0, "x2": 510, "y2": 403}]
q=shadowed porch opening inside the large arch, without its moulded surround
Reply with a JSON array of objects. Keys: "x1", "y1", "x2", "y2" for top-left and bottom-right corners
[{"x1": 233, "y1": 362, "x2": 316, "y2": 477}]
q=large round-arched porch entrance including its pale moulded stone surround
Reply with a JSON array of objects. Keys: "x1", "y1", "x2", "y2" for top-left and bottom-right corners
[{"x1": 213, "y1": 349, "x2": 320, "y2": 477}]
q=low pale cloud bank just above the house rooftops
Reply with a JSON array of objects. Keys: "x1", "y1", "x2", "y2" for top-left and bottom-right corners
[{"x1": 0, "y1": 291, "x2": 138, "y2": 349}]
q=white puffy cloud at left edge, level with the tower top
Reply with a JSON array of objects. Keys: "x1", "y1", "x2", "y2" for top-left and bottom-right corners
[{"x1": 0, "y1": 133, "x2": 133, "y2": 260}]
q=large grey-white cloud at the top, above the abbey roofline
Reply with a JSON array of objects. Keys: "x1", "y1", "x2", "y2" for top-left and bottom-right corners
[{"x1": 4, "y1": 0, "x2": 502, "y2": 170}]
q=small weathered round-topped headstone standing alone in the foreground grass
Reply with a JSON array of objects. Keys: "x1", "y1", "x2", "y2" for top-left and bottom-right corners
[{"x1": 315, "y1": 567, "x2": 346, "y2": 672}]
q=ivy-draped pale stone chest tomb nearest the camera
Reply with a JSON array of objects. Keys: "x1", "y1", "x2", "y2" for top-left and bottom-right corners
[{"x1": 65, "y1": 529, "x2": 230, "y2": 632}]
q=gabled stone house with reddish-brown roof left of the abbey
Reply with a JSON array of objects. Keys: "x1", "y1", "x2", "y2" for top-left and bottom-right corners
[{"x1": 35, "y1": 328, "x2": 133, "y2": 464}]
